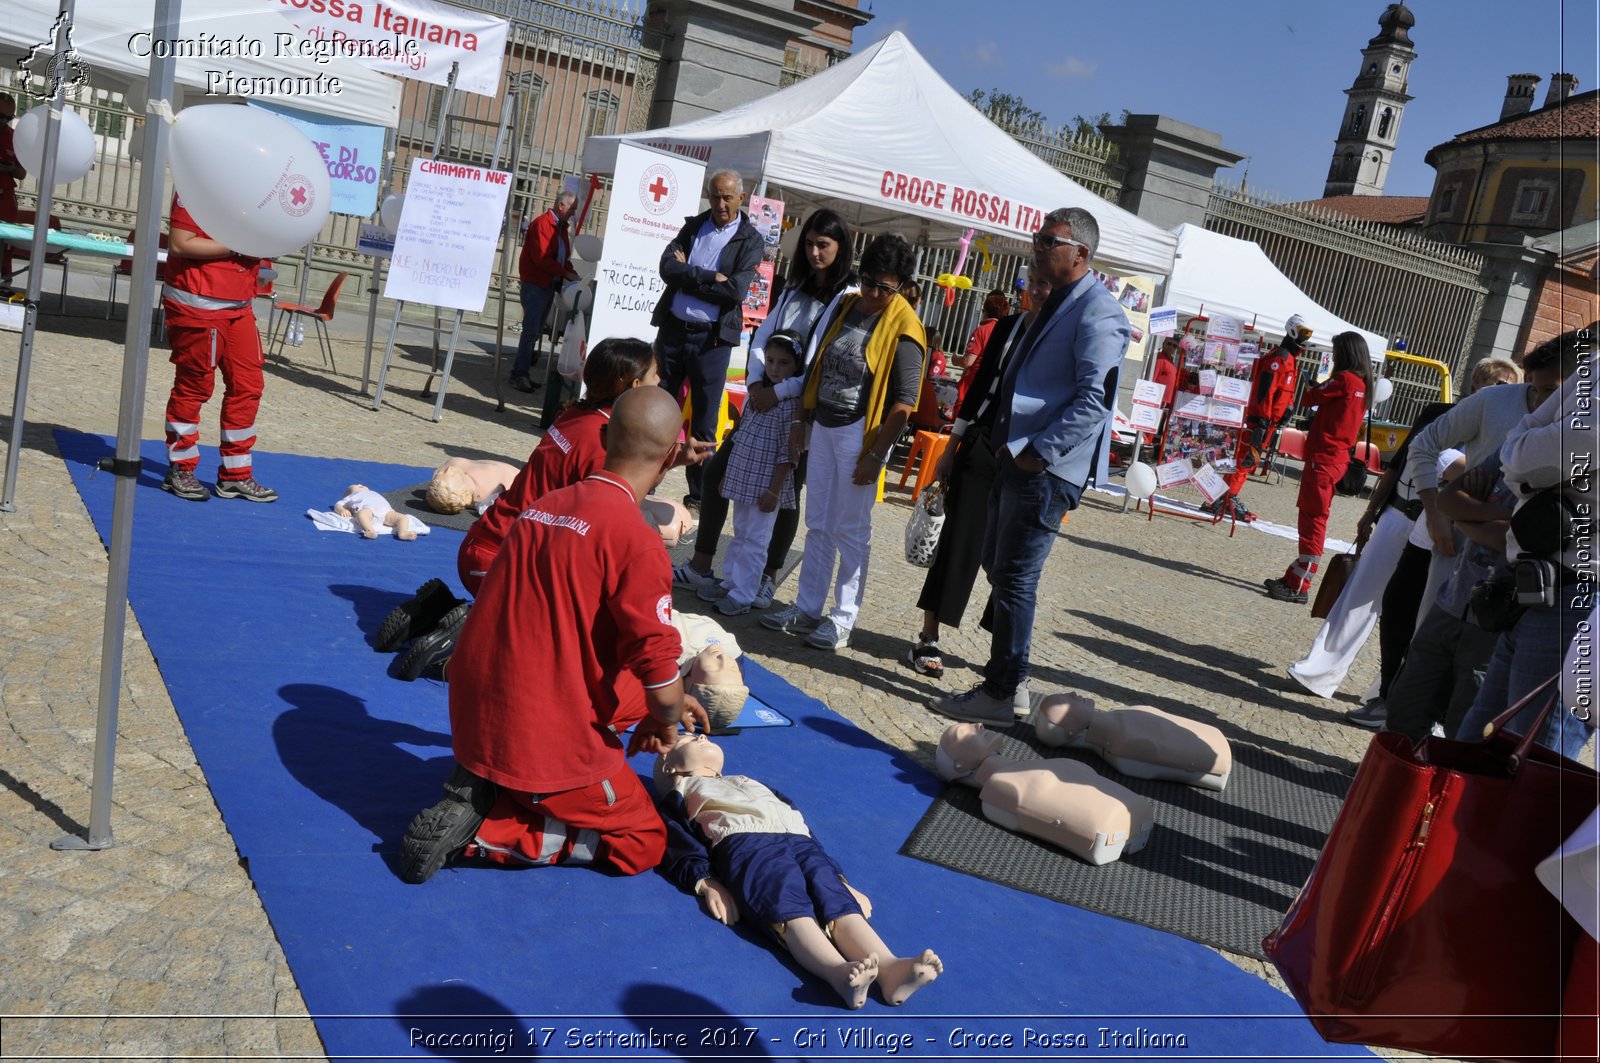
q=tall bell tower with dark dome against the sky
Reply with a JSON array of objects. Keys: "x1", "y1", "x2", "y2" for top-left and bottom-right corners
[{"x1": 1322, "y1": 3, "x2": 1416, "y2": 197}]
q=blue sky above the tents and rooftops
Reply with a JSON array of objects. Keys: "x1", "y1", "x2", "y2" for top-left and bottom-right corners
[{"x1": 856, "y1": 0, "x2": 1600, "y2": 200}]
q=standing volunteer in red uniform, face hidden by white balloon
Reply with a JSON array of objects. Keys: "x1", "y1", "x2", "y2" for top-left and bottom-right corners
[{"x1": 162, "y1": 195, "x2": 278, "y2": 503}]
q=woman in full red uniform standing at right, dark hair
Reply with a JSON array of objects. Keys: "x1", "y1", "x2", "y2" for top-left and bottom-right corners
[{"x1": 1264, "y1": 333, "x2": 1373, "y2": 602}]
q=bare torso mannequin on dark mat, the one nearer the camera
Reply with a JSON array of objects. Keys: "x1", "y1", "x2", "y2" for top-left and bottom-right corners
[{"x1": 936, "y1": 724, "x2": 1155, "y2": 864}]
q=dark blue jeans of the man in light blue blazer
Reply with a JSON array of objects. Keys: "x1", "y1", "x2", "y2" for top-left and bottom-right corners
[{"x1": 979, "y1": 454, "x2": 1083, "y2": 698}]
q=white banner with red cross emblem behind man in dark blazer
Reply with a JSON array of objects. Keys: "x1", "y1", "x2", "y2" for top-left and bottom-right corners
[{"x1": 589, "y1": 144, "x2": 706, "y2": 341}]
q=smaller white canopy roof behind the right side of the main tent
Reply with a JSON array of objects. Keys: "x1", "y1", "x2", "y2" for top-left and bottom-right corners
[{"x1": 1166, "y1": 223, "x2": 1389, "y2": 359}]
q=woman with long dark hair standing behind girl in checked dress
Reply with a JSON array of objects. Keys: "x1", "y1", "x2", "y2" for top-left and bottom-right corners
[{"x1": 672, "y1": 208, "x2": 856, "y2": 608}]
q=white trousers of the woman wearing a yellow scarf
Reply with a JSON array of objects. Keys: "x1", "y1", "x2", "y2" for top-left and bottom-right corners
[{"x1": 795, "y1": 421, "x2": 878, "y2": 631}]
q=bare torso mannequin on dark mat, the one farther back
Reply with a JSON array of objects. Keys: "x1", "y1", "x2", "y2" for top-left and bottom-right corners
[{"x1": 1034, "y1": 693, "x2": 1234, "y2": 789}]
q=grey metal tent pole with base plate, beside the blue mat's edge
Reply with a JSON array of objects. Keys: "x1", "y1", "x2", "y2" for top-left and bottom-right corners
[{"x1": 50, "y1": 0, "x2": 182, "y2": 850}]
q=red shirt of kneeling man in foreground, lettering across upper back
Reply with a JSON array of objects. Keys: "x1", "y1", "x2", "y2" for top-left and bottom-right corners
[{"x1": 448, "y1": 471, "x2": 682, "y2": 794}]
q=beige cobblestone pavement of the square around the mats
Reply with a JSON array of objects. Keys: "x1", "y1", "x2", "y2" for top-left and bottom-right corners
[{"x1": 0, "y1": 280, "x2": 1378, "y2": 1058}]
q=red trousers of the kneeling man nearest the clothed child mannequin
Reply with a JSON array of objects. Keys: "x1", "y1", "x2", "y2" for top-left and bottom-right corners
[{"x1": 467, "y1": 768, "x2": 667, "y2": 874}]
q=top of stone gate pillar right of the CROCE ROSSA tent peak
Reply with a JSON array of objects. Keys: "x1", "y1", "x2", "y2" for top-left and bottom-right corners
[{"x1": 1101, "y1": 114, "x2": 1243, "y2": 229}]
